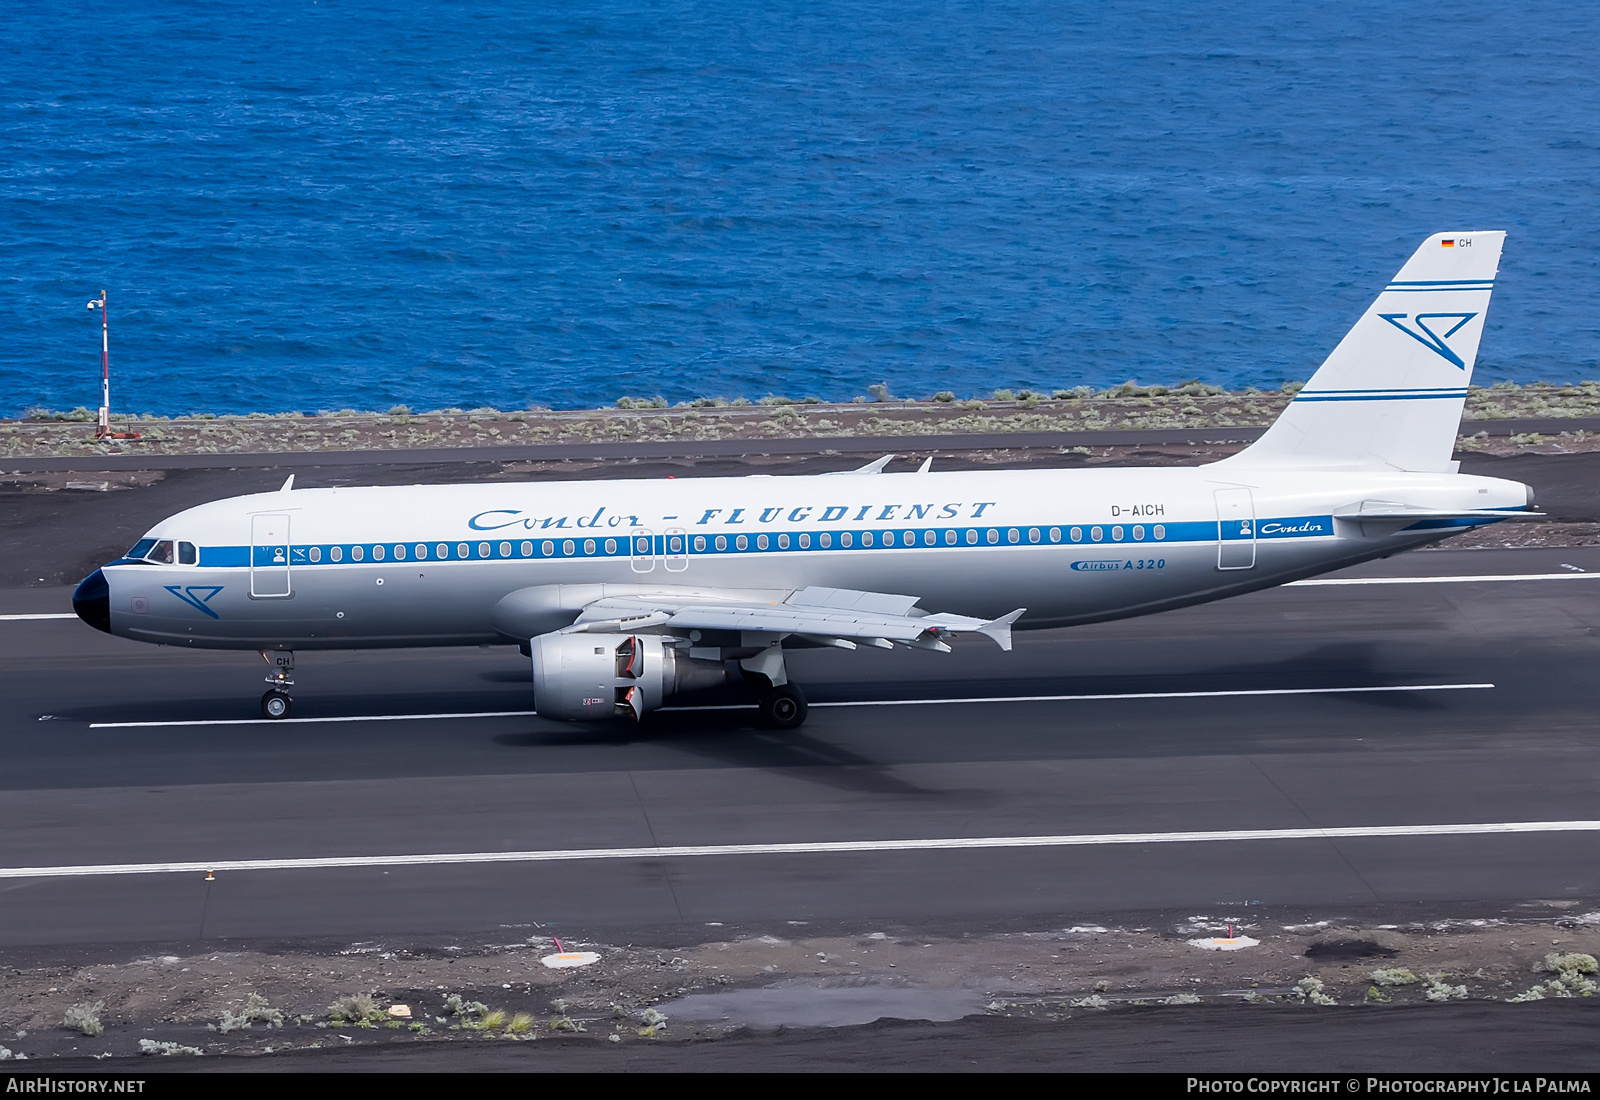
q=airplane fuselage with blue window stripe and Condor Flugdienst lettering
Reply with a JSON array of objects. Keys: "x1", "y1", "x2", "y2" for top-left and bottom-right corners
[{"x1": 81, "y1": 467, "x2": 1530, "y2": 649}]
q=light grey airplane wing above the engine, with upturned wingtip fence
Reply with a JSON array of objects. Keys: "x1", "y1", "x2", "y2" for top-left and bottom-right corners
[{"x1": 563, "y1": 587, "x2": 1024, "y2": 652}]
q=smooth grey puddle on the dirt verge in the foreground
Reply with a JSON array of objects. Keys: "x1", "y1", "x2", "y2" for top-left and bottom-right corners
[{"x1": 661, "y1": 982, "x2": 984, "y2": 1028}]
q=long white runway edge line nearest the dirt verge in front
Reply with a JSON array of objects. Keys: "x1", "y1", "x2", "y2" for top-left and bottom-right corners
[{"x1": 0, "y1": 822, "x2": 1600, "y2": 879}]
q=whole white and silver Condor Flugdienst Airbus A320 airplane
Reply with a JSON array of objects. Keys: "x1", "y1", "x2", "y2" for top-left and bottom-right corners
[{"x1": 72, "y1": 232, "x2": 1533, "y2": 727}]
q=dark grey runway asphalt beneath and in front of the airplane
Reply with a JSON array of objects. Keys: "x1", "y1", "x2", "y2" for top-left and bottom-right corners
[{"x1": 0, "y1": 548, "x2": 1600, "y2": 948}]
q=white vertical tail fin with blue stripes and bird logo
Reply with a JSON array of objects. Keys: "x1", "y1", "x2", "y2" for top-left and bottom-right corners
[{"x1": 1226, "y1": 232, "x2": 1506, "y2": 472}]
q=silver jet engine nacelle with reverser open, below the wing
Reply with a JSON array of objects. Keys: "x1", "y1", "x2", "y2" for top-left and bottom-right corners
[{"x1": 528, "y1": 633, "x2": 726, "y2": 721}]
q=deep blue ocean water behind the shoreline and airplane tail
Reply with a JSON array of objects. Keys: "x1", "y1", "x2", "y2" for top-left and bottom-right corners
[{"x1": 0, "y1": 0, "x2": 1600, "y2": 414}]
